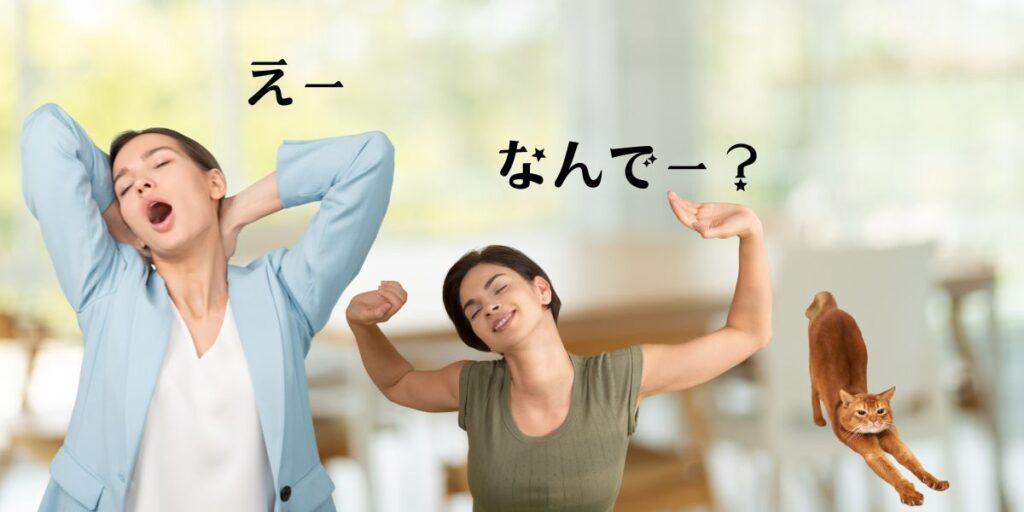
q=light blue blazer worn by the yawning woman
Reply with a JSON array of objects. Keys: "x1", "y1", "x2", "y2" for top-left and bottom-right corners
[{"x1": 22, "y1": 103, "x2": 394, "y2": 512}]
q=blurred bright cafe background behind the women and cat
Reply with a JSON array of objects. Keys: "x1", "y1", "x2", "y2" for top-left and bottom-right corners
[{"x1": 0, "y1": 0, "x2": 1024, "y2": 512}]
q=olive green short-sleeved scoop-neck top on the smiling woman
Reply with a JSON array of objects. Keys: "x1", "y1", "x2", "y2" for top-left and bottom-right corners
[{"x1": 459, "y1": 345, "x2": 642, "y2": 512}]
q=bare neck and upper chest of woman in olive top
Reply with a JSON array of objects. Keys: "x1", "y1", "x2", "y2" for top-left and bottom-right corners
[{"x1": 505, "y1": 321, "x2": 575, "y2": 402}]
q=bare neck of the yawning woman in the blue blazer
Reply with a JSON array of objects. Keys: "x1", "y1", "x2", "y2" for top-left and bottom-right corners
[{"x1": 153, "y1": 223, "x2": 227, "y2": 318}]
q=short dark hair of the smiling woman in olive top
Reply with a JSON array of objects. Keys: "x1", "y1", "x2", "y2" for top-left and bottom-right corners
[{"x1": 441, "y1": 245, "x2": 562, "y2": 352}]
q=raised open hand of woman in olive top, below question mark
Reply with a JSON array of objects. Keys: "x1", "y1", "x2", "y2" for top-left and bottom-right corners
[{"x1": 669, "y1": 191, "x2": 762, "y2": 239}]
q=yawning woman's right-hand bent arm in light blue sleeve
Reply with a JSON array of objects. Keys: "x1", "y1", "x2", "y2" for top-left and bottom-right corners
[{"x1": 258, "y1": 131, "x2": 394, "y2": 344}]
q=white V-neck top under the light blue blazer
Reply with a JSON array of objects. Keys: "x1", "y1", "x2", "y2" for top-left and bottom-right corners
[{"x1": 126, "y1": 302, "x2": 274, "y2": 512}]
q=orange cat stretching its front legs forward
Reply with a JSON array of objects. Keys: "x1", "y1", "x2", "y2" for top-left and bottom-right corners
[{"x1": 805, "y1": 292, "x2": 949, "y2": 505}]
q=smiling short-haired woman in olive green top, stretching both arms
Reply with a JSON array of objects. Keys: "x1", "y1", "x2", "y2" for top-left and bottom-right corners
[{"x1": 346, "y1": 193, "x2": 771, "y2": 511}]
